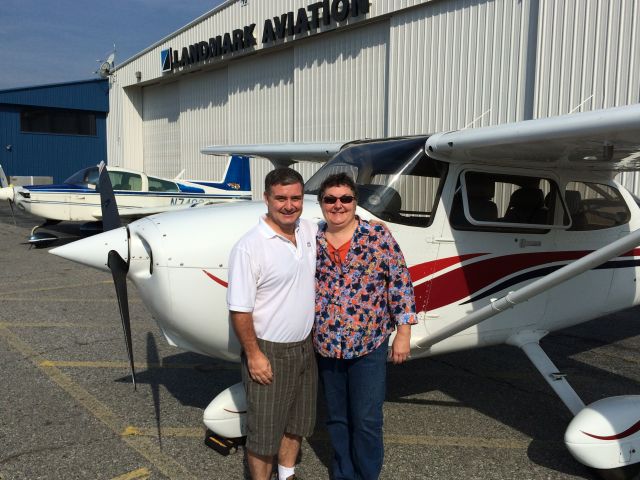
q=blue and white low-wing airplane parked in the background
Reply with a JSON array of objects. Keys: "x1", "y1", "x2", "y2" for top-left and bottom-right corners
[{"x1": 0, "y1": 155, "x2": 251, "y2": 247}]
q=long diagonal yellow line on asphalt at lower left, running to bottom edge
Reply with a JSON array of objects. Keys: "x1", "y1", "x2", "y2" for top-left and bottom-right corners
[{"x1": 0, "y1": 328, "x2": 195, "y2": 480}]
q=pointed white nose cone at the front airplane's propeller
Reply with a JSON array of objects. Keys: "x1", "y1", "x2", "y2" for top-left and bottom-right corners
[{"x1": 49, "y1": 227, "x2": 129, "y2": 272}]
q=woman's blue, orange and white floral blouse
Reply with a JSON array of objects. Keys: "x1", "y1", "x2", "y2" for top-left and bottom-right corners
[{"x1": 313, "y1": 218, "x2": 418, "y2": 359}]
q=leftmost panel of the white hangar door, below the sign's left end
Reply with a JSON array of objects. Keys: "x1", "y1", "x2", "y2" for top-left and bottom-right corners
[{"x1": 142, "y1": 82, "x2": 181, "y2": 178}]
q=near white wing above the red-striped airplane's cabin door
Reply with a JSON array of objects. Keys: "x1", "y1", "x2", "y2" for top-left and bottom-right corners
[{"x1": 426, "y1": 104, "x2": 640, "y2": 172}]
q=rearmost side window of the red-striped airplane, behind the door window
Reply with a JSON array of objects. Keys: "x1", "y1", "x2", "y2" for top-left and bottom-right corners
[{"x1": 564, "y1": 182, "x2": 631, "y2": 231}]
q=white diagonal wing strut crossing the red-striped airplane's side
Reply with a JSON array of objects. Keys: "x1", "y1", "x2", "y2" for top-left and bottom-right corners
[{"x1": 412, "y1": 229, "x2": 640, "y2": 348}]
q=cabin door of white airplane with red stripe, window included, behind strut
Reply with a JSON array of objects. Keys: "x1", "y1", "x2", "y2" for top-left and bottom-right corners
[{"x1": 425, "y1": 167, "x2": 558, "y2": 353}]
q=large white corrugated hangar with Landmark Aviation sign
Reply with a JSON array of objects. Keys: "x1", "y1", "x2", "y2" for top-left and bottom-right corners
[{"x1": 108, "y1": 0, "x2": 640, "y2": 196}]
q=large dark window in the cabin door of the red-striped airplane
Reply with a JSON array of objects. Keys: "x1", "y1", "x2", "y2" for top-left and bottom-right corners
[{"x1": 450, "y1": 171, "x2": 568, "y2": 233}]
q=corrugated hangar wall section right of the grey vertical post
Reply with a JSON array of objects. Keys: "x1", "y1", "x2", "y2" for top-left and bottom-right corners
[{"x1": 535, "y1": 0, "x2": 640, "y2": 117}]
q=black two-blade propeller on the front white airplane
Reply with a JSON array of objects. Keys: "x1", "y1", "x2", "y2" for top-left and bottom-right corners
[{"x1": 98, "y1": 162, "x2": 136, "y2": 389}]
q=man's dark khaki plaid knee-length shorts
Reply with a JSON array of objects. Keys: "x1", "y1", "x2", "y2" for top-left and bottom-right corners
[{"x1": 242, "y1": 336, "x2": 318, "y2": 456}]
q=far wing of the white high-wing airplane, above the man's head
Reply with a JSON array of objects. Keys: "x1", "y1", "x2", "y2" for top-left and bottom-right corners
[{"x1": 200, "y1": 142, "x2": 346, "y2": 166}]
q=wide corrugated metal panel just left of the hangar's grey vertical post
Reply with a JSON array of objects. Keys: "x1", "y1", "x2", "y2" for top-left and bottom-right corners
[{"x1": 389, "y1": 0, "x2": 529, "y2": 135}]
